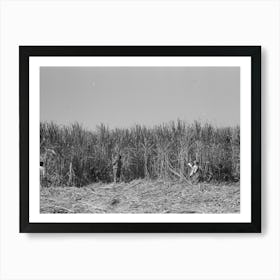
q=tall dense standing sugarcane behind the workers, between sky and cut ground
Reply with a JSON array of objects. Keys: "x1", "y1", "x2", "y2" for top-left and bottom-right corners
[{"x1": 40, "y1": 120, "x2": 240, "y2": 186}]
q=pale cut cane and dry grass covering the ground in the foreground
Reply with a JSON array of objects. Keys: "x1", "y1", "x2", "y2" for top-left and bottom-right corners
[{"x1": 40, "y1": 180, "x2": 240, "y2": 213}]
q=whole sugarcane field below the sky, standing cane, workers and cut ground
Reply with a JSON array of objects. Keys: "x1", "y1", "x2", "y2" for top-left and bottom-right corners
[{"x1": 40, "y1": 120, "x2": 240, "y2": 213}]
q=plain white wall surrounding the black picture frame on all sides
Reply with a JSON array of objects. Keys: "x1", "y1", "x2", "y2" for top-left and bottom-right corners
[{"x1": 0, "y1": 0, "x2": 280, "y2": 280}]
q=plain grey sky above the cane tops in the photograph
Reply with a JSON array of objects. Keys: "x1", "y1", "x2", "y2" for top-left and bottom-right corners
[{"x1": 40, "y1": 67, "x2": 240, "y2": 129}]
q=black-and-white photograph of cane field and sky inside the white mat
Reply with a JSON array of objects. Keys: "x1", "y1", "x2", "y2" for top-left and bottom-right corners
[{"x1": 40, "y1": 67, "x2": 240, "y2": 214}]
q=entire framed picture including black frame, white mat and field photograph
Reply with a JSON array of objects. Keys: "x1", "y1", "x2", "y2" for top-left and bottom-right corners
[{"x1": 20, "y1": 47, "x2": 260, "y2": 232}]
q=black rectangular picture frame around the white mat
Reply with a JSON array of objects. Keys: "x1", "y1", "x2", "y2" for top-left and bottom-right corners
[{"x1": 19, "y1": 46, "x2": 261, "y2": 233}]
